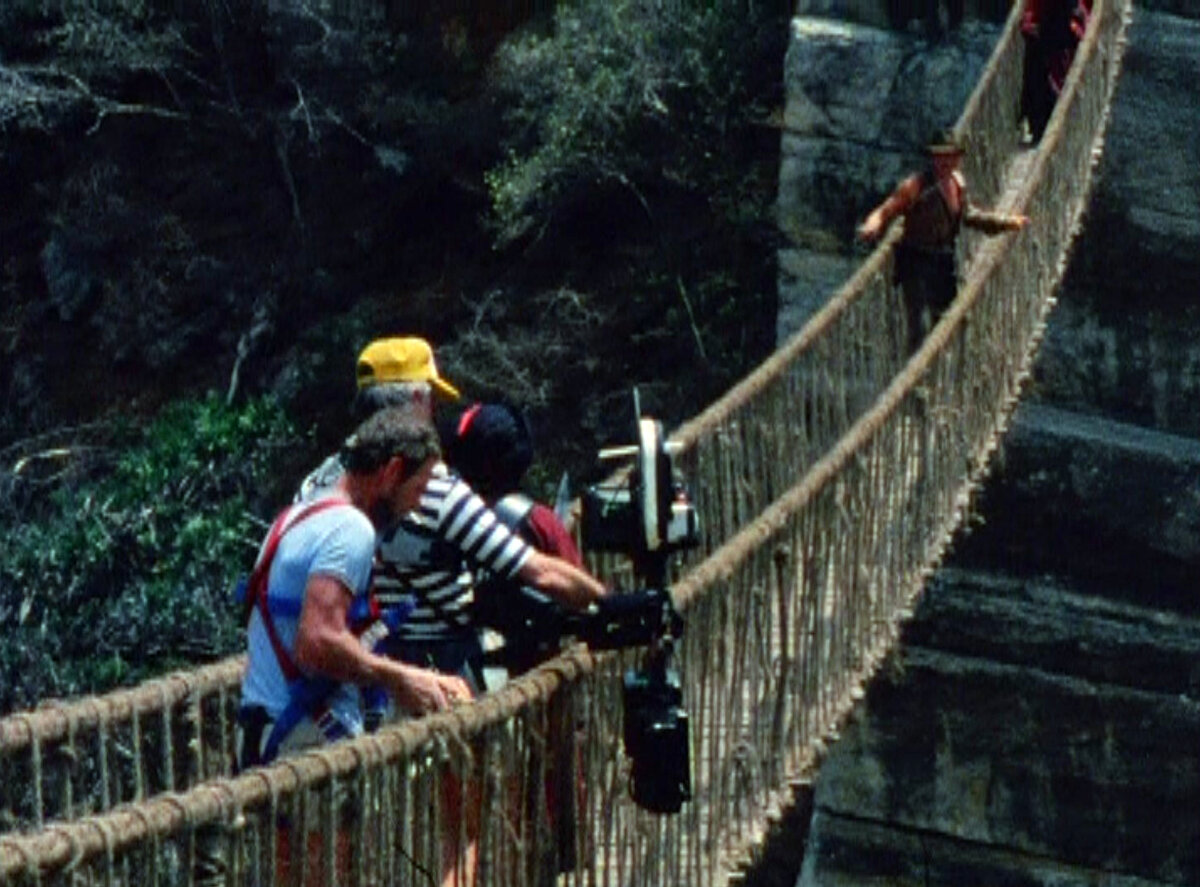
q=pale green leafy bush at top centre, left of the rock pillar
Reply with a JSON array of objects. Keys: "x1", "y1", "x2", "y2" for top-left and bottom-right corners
[{"x1": 487, "y1": 0, "x2": 786, "y2": 244}]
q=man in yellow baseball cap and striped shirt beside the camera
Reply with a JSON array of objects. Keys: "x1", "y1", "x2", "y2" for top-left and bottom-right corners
[{"x1": 296, "y1": 337, "x2": 607, "y2": 883}]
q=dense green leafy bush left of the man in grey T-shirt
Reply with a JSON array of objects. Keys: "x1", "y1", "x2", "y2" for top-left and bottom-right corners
[{"x1": 0, "y1": 397, "x2": 296, "y2": 711}]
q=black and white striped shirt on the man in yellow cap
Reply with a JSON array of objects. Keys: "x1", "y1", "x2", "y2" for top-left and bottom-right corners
[{"x1": 374, "y1": 465, "x2": 532, "y2": 640}]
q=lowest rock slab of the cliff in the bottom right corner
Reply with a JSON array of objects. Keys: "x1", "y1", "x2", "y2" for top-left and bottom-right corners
[{"x1": 802, "y1": 643, "x2": 1200, "y2": 885}]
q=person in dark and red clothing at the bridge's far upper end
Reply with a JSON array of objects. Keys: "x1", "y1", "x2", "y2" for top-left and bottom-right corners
[{"x1": 1021, "y1": 0, "x2": 1092, "y2": 144}]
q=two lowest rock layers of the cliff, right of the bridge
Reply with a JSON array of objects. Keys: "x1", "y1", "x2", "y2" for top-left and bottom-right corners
[{"x1": 799, "y1": 573, "x2": 1200, "y2": 887}]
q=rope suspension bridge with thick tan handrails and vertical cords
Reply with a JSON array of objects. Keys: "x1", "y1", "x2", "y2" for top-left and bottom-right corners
[{"x1": 0, "y1": 0, "x2": 1130, "y2": 887}]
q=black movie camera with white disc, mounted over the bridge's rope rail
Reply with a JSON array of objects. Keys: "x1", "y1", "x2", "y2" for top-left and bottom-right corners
[{"x1": 474, "y1": 391, "x2": 700, "y2": 813}]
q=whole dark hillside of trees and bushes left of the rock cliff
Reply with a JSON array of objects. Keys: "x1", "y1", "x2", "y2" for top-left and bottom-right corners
[{"x1": 0, "y1": 0, "x2": 787, "y2": 708}]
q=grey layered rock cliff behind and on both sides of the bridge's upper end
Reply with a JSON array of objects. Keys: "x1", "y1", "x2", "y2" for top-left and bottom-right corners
[{"x1": 780, "y1": 0, "x2": 1200, "y2": 887}]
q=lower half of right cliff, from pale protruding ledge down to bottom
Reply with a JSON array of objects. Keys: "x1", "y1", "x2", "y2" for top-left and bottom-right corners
[{"x1": 798, "y1": 407, "x2": 1200, "y2": 887}]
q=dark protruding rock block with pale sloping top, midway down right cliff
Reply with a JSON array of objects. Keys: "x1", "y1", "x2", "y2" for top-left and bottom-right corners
[{"x1": 958, "y1": 403, "x2": 1200, "y2": 597}]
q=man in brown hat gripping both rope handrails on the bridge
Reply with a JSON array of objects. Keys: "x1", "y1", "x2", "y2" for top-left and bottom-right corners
[{"x1": 858, "y1": 132, "x2": 1030, "y2": 353}]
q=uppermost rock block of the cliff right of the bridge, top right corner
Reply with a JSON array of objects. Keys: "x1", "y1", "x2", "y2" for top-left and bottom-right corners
[{"x1": 1037, "y1": 8, "x2": 1200, "y2": 436}]
